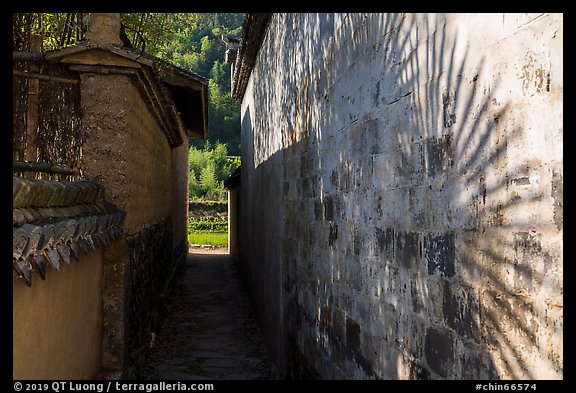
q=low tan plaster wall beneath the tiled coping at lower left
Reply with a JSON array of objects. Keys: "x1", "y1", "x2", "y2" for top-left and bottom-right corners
[{"x1": 12, "y1": 248, "x2": 103, "y2": 380}]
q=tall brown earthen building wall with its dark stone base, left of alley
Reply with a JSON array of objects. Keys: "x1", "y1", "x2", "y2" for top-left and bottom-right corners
[{"x1": 82, "y1": 74, "x2": 188, "y2": 375}]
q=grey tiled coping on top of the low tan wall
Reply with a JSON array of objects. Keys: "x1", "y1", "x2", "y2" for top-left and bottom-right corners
[{"x1": 12, "y1": 176, "x2": 125, "y2": 286}]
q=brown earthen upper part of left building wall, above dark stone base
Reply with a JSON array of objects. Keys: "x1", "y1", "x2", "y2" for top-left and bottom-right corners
[{"x1": 82, "y1": 75, "x2": 172, "y2": 230}]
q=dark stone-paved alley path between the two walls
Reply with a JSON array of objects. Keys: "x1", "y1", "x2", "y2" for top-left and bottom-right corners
[{"x1": 138, "y1": 251, "x2": 275, "y2": 380}]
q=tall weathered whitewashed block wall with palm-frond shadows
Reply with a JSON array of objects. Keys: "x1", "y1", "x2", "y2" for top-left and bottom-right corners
[{"x1": 241, "y1": 14, "x2": 563, "y2": 379}]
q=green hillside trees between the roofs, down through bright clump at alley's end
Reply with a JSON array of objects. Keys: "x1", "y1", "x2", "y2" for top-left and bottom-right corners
[{"x1": 122, "y1": 13, "x2": 245, "y2": 193}]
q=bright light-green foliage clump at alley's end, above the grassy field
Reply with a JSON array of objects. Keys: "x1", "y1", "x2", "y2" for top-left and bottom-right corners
[{"x1": 188, "y1": 142, "x2": 239, "y2": 200}]
